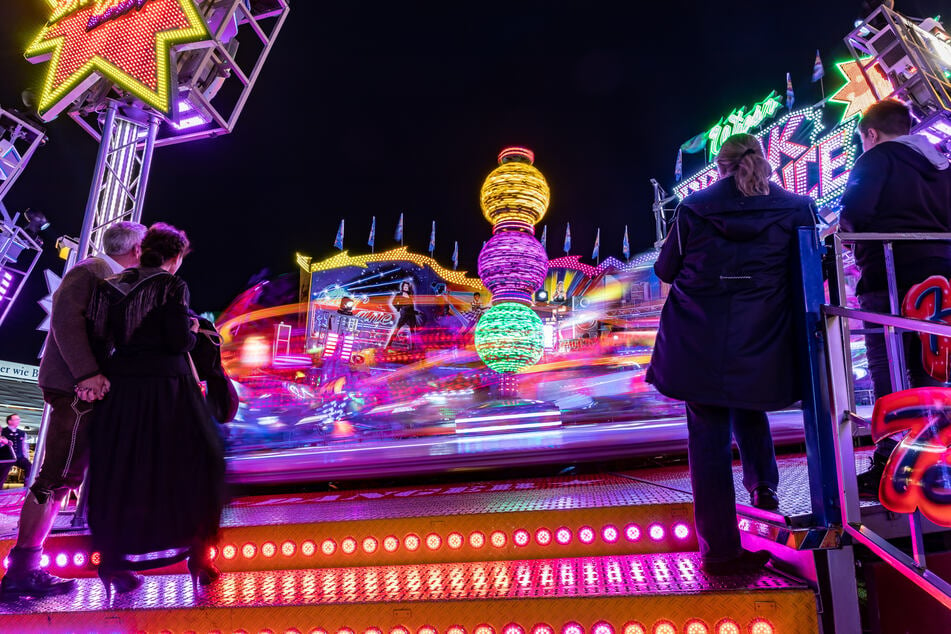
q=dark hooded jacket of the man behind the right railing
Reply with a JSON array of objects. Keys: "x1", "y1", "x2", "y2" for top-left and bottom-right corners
[{"x1": 839, "y1": 141, "x2": 951, "y2": 294}]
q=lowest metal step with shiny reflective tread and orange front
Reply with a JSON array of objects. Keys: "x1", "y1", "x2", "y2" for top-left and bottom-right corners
[{"x1": 0, "y1": 553, "x2": 818, "y2": 634}]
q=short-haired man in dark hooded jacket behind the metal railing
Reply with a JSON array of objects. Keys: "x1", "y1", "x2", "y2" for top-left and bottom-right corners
[{"x1": 839, "y1": 100, "x2": 951, "y2": 499}]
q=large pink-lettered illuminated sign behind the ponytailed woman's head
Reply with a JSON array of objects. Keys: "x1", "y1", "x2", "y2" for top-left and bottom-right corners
[{"x1": 674, "y1": 106, "x2": 858, "y2": 207}]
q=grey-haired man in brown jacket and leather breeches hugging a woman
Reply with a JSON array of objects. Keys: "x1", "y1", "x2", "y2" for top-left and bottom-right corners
[{"x1": 0, "y1": 222, "x2": 145, "y2": 597}]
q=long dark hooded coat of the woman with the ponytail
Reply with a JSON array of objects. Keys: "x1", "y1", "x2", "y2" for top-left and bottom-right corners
[{"x1": 647, "y1": 178, "x2": 816, "y2": 411}]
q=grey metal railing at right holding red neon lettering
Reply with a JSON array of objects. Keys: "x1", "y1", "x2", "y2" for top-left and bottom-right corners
[{"x1": 821, "y1": 233, "x2": 951, "y2": 609}]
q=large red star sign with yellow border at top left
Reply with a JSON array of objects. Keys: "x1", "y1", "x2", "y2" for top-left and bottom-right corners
[{"x1": 26, "y1": 0, "x2": 210, "y2": 119}]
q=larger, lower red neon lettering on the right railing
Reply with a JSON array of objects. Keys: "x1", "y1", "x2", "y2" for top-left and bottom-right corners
[{"x1": 872, "y1": 387, "x2": 951, "y2": 526}]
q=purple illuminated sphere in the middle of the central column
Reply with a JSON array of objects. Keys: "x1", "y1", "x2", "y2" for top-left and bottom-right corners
[{"x1": 479, "y1": 231, "x2": 548, "y2": 304}]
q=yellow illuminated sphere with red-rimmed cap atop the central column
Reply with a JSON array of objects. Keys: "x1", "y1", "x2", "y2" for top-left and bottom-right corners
[{"x1": 480, "y1": 148, "x2": 551, "y2": 226}]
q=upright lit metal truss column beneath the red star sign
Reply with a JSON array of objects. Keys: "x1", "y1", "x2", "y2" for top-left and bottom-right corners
[{"x1": 78, "y1": 102, "x2": 160, "y2": 260}]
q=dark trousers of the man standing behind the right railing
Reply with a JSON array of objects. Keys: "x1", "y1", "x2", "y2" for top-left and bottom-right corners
[{"x1": 858, "y1": 290, "x2": 944, "y2": 464}]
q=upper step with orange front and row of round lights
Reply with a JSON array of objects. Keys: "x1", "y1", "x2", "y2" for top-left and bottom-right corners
[{"x1": 0, "y1": 474, "x2": 697, "y2": 576}]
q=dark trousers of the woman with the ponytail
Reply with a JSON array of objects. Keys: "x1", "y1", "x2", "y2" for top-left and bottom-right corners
[{"x1": 687, "y1": 403, "x2": 779, "y2": 561}]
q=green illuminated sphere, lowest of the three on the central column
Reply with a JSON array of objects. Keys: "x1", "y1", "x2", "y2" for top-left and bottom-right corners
[{"x1": 475, "y1": 302, "x2": 545, "y2": 374}]
